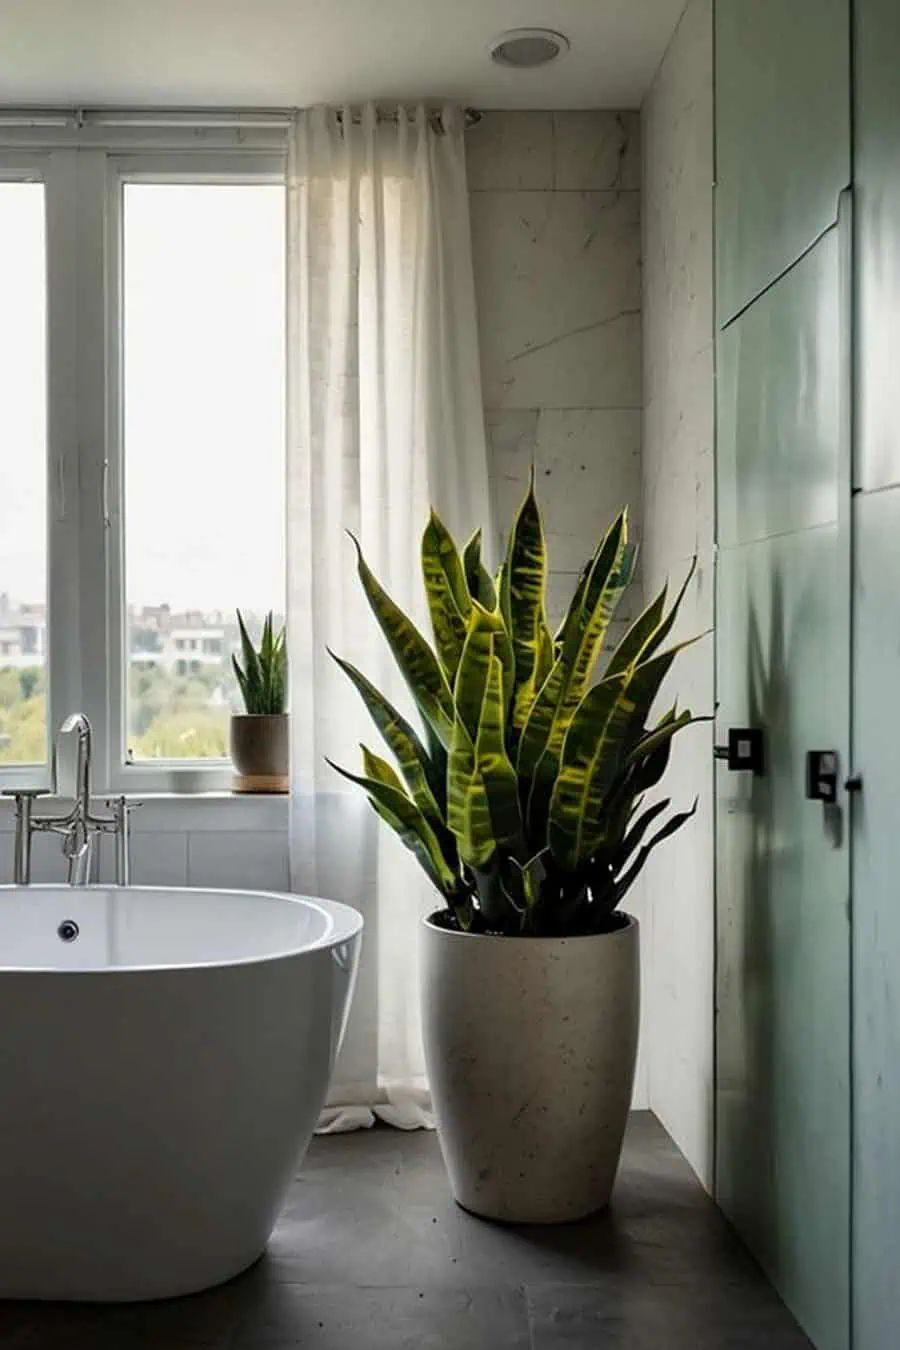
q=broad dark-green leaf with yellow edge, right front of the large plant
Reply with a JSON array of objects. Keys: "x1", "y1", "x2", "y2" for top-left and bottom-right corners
[{"x1": 546, "y1": 674, "x2": 634, "y2": 872}]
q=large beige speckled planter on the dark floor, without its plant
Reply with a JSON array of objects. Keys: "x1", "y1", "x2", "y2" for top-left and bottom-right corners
[{"x1": 422, "y1": 915, "x2": 640, "y2": 1223}]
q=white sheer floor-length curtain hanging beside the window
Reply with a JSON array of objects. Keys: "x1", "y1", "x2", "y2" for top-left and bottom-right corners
[{"x1": 287, "y1": 105, "x2": 491, "y2": 1130}]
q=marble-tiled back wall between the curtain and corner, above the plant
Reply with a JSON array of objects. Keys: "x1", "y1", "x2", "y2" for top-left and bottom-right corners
[{"x1": 466, "y1": 112, "x2": 641, "y2": 648}]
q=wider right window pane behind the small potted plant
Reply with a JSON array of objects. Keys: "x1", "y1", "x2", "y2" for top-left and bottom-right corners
[{"x1": 123, "y1": 184, "x2": 285, "y2": 760}]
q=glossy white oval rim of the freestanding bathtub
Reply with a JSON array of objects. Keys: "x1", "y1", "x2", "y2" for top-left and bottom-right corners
[{"x1": 0, "y1": 882, "x2": 364, "y2": 977}]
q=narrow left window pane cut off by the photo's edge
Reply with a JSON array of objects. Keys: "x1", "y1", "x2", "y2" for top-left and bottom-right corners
[{"x1": 0, "y1": 182, "x2": 47, "y2": 764}]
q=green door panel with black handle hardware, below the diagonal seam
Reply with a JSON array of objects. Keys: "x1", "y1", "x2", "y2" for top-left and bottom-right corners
[{"x1": 715, "y1": 225, "x2": 850, "y2": 1350}]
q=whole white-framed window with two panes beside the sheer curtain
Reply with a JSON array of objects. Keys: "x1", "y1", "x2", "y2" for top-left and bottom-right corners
[{"x1": 0, "y1": 122, "x2": 285, "y2": 791}]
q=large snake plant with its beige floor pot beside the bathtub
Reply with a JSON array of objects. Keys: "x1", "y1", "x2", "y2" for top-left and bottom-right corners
[{"x1": 333, "y1": 479, "x2": 696, "y2": 1223}]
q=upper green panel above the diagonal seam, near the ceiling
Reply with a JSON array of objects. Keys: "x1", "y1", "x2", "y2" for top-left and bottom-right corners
[{"x1": 715, "y1": 0, "x2": 850, "y2": 325}]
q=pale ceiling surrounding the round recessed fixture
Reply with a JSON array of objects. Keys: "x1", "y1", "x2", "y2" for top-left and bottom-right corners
[{"x1": 0, "y1": 0, "x2": 684, "y2": 108}]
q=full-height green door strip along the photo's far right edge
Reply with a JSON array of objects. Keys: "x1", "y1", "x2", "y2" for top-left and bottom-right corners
[{"x1": 853, "y1": 0, "x2": 900, "y2": 1350}]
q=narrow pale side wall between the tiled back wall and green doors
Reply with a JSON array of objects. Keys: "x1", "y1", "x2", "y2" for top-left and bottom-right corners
[{"x1": 641, "y1": 0, "x2": 714, "y2": 1185}]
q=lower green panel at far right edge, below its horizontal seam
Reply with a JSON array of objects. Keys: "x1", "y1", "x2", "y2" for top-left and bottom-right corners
[{"x1": 853, "y1": 487, "x2": 900, "y2": 1350}]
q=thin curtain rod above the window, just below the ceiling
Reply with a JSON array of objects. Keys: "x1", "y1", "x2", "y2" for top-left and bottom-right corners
[{"x1": 0, "y1": 108, "x2": 482, "y2": 128}]
